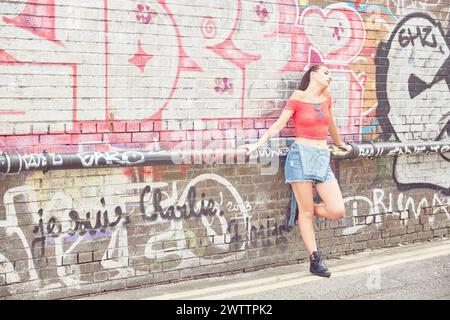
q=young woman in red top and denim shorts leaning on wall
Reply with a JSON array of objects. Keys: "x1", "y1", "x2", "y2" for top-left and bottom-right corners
[{"x1": 241, "y1": 65, "x2": 351, "y2": 277}]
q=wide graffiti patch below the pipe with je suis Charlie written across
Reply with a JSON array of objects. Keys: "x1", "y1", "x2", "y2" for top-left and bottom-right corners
[{"x1": 0, "y1": 174, "x2": 292, "y2": 289}]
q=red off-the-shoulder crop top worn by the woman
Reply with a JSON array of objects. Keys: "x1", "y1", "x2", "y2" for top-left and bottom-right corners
[{"x1": 283, "y1": 98, "x2": 333, "y2": 140}]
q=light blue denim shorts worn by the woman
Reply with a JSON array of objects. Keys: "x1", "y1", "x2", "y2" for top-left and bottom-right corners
[{"x1": 284, "y1": 143, "x2": 336, "y2": 184}]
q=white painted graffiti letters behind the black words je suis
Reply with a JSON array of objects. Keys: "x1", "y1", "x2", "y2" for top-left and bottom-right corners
[{"x1": 0, "y1": 186, "x2": 129, "y2": 289}]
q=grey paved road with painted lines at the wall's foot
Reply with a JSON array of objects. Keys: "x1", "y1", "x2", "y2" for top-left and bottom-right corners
[{"x1": 75, "y1": 239, "x2": 450, "y2": 300}]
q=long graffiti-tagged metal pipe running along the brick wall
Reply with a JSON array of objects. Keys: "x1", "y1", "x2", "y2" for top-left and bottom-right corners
[{"x1": 0, "y1": 140, "x2": 450, "y2": 174}]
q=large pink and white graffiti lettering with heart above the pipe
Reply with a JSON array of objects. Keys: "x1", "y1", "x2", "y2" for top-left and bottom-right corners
[{"x1": 0, "y1": 0, "x2": 366, "y2": 146}]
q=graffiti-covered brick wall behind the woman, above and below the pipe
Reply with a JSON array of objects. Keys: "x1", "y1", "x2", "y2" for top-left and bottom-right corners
[{"x1": 0, "y1": 0, "x2": 450, "y2": 298}]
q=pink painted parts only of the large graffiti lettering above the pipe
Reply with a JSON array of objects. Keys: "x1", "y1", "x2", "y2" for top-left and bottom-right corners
[{"x1": 0, "y1": 0, "x2": 365, "y2": 151}]
